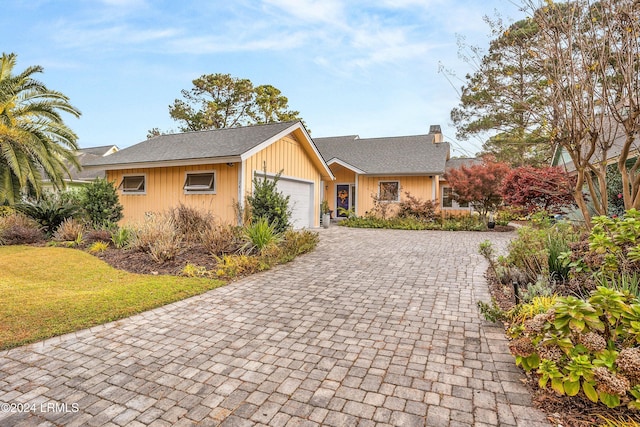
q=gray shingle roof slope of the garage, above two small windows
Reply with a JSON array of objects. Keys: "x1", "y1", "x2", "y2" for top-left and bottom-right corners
[{"x1": 86, "y1": 121, "x2": 298, "y2": 166}]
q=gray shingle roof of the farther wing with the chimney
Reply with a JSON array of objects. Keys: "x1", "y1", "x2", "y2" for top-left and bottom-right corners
[{"x1": 313, "y1": 134, "x2": 449, "y2": 175}]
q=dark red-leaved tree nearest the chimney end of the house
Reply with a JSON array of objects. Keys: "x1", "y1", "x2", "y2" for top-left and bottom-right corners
[{"x1": 444, "y1": 156, "x2": 510, "y2": 218}]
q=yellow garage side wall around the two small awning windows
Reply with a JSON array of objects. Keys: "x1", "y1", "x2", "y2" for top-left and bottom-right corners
[{"x1": 107, "y1": 164, "x2": 239, "y2": 224}]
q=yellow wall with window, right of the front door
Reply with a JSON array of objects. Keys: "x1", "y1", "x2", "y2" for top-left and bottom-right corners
[{"x1": 356, "y1": 175, "x2": 440, "y2": 216}]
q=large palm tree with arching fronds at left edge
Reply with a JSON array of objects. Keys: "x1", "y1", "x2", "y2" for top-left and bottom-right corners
[{"x1": 0, "y1": 53, "x2": 80, "y2": 204}]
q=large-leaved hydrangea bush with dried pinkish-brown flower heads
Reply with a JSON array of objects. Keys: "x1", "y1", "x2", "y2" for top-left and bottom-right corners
[{"x1": 509, "y1": 286, "x2": 640, "y2": 408}]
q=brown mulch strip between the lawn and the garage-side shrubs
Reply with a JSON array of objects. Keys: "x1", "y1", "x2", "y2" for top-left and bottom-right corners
[{"x1": 96, "y1": 246, "x2": 217, "y2": 276}]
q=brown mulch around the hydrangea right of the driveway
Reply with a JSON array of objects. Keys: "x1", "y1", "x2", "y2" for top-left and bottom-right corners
[{"x1": 486, "y1": 270, "x2": 640, "y2": 427}]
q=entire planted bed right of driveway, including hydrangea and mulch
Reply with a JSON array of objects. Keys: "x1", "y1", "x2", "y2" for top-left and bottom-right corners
[{"x1": 479, "y1": 210, "x2": 640, "y2": 427}]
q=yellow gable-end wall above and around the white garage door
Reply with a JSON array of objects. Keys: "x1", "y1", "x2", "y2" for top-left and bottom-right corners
[{"x1": 243, "y1": 134, "x2": 321, "y2": 227}]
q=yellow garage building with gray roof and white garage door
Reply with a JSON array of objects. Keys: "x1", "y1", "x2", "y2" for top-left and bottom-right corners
[{"x1": 85, "y1": 121, "x2": 334, "y2": 228}]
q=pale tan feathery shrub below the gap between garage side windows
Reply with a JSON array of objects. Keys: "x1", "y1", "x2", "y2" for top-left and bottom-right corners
[{"x1": 129, "y1": 215, "x2": 182, "y2": 264}]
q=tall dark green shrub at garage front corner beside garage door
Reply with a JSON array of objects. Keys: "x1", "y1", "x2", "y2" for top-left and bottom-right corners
[{"x1": 247, "y1": 171, "x2": 291, "y2": 233}]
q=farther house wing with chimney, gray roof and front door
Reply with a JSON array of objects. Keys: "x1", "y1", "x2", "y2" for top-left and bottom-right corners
[{"x1": 314, "y1": 125, "x2": 469, "y2": 218}]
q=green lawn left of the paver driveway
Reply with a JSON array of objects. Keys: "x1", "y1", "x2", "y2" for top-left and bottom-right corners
[{"x1": 0, "y1": 246, "x2": 225, "y2": 349}]
